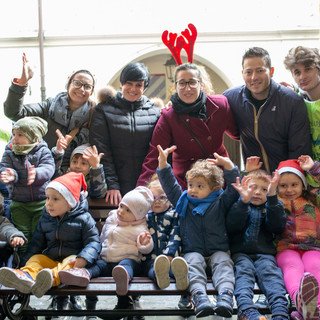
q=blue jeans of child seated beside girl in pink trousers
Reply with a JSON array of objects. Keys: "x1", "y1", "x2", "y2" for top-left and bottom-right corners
[{"x1": 232, "y1": 253, "x2": 289, "y2": 317}]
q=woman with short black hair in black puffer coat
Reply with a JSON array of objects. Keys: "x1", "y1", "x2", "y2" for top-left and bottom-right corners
[{"x1": 90, "y1": 62, "x2": 160, "y2": 206}]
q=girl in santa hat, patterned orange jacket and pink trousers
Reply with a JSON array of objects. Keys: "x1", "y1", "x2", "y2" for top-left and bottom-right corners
[{"x1": 276, "y1": 156, "x2": 320, "y2": 320}]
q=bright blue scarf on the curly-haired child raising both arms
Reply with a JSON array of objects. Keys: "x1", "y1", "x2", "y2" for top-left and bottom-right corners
[{"x1": 176, "y1": 189, "x2": 222, "y2": 218}]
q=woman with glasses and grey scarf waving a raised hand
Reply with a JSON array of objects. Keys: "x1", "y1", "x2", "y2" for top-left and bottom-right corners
[{"x1": 4, "y1": 54, "x2": 95, "y2": 169}]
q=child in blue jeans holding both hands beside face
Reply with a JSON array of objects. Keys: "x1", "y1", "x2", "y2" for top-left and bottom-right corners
[{"x1": 227, "y1": 168, "x2": 289, "y2": 320}]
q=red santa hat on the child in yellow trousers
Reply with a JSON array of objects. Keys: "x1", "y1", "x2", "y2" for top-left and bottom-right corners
[{"x1": 46, "y1": 172, "x2": 87, "y2": 208}]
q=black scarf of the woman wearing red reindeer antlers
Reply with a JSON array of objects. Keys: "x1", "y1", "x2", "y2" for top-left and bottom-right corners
[{"x1": 170, "y1": 91, "x2": 207, "y2": 120}]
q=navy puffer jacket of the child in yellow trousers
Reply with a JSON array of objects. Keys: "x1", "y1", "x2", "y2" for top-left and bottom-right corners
[{"x1": 21, "y1": 195, "x2": 101, "y2": 266}]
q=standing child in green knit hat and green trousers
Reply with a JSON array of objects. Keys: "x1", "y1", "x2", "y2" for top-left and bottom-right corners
[{"x1": 0, "y1": 117, "x2": 55, "y2": 256}]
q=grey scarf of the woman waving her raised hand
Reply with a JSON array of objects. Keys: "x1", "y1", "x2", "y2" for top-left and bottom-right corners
[{"x1": 49, "y1": 92, "x2": 90, "y2": 132}]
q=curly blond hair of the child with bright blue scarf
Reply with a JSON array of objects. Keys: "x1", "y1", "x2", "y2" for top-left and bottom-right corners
[{"x1": 186, "y1": 160, "x2": 224, "y2": 189}]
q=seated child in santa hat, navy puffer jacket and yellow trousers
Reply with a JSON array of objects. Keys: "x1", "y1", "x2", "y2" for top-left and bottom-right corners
[{"x1": 0, "y1": 172, "x2": 101, "y2": 298}]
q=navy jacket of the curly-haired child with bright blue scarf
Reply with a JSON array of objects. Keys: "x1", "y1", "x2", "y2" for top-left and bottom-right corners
[{"x1": 157, "y1": 164, "x2": 240, "y2": 257}]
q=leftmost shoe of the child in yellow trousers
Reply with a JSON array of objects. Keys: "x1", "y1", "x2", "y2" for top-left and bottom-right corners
[{"x1": 0, "y1": 267, "x2": 34, "y2": 293}]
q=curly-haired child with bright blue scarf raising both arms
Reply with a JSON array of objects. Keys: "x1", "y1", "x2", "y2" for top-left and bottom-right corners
[{"x1": 157, "y1": 145, "x2": 240, "y2": 318}]
